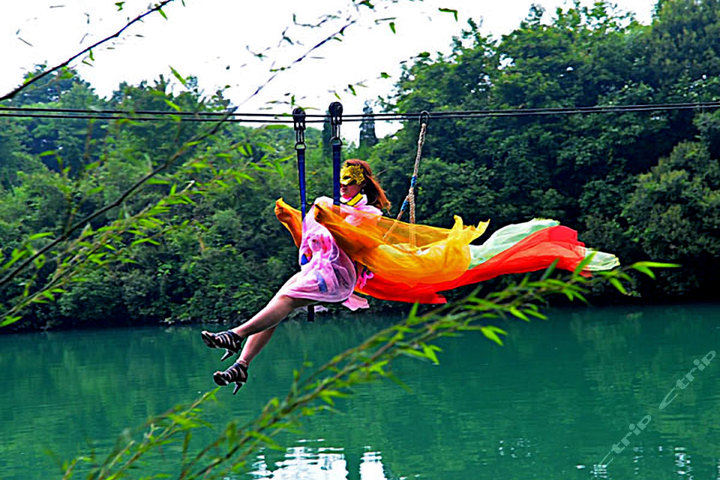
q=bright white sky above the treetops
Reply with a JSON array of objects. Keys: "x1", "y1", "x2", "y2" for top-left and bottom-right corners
[{"x1": 0, "y1": 0, "x2": 655, "y2": 139}]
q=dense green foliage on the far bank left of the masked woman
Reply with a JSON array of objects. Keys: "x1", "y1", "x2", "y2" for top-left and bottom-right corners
[{"x1": 0, "y1": 72, "x2": 330, "y2": 327}]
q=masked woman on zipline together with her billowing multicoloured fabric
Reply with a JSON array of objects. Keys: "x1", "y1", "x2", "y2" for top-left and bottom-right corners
[{"x1": 202, "y1": 160, "x2": 619, "y2": 392}]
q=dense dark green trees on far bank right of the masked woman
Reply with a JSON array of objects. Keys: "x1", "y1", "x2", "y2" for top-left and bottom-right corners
[{"x1": 371, "y1": 0, "x2": 720, "y2": 299}]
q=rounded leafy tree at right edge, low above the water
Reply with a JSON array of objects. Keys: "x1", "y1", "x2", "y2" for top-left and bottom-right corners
[{"x1": 624, "y1": 142, "x2": 720, "y2": 294}]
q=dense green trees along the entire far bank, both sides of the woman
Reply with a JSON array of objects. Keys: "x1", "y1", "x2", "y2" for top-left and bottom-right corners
[{"x1": 0, "y1": 0, "x2": 720, "y2": 328}]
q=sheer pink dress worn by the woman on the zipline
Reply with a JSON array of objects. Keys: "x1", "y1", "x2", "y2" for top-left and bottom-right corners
[{"x1": 278, "y1": 195, "x2": 381, "y2": 310}]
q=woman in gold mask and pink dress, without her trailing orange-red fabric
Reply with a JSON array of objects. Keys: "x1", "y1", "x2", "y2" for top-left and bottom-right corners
[{"x1": 202, "y1": 160, "x2": 390, "y2": 392}]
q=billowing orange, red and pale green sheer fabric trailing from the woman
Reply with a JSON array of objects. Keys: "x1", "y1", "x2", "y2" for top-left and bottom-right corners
[{"x1": 276, "y1": 199, "x2": 619, "y2": 303}]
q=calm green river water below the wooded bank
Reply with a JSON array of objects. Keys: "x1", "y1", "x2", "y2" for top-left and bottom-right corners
[{"x1": 0, "y1": 304, "x2": 720, "y2": 480}]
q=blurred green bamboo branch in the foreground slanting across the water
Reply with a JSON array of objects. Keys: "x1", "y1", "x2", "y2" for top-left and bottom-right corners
[{"x1": 64, "y1": 262, "x2": 671, "y2": 480}]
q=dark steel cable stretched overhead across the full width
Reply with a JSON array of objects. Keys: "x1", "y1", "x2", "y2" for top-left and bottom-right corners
[{"x1": 0, "y1": 101, "x2": 720, "y2": 125}]
